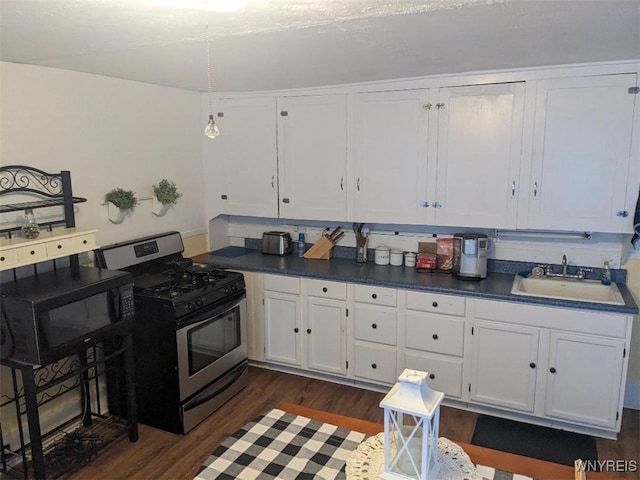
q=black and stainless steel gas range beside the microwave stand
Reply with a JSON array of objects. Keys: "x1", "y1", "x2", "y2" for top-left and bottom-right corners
[{"x1": 95, "y1": 232, "x2": 248, "y2": 433}]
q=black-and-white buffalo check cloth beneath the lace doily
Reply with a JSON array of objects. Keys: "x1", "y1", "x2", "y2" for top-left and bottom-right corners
[{"x1": 194, "y1": 409, "x2": 531, "y2": 480}]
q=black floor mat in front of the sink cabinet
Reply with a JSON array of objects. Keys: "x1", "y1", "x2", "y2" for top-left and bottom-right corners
[{"x1": 471, "y1": 415, "x2": 598, "y2": 466}]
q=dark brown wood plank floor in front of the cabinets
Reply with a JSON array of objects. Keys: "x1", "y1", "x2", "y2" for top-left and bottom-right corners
[{"x1": 70, "y1": 367, "x2": 640, "y2": 480}]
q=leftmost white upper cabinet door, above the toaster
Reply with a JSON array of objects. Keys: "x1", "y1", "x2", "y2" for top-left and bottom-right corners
[{"x1": 210, "y1": 97, "x2": 278, "y2": 217}]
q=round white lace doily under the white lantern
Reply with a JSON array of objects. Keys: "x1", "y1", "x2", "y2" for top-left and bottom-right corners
[{"x1": 346, "y1": 433, "x2": 482, "y2": 480}]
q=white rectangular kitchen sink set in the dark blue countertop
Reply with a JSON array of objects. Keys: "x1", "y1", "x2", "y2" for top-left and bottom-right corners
[{"x1": 511, "y1": 275, "x2": 624, "y2": 305}]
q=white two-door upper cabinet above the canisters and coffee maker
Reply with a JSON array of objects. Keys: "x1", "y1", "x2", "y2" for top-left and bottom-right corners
[{"x1": 351, "y1": 82, "x2": 524, "y2": 228}]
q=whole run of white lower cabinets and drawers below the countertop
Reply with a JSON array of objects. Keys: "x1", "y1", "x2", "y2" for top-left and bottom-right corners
[{"x1": 258, "y1": 274, "x2": 633, "y2": 438}]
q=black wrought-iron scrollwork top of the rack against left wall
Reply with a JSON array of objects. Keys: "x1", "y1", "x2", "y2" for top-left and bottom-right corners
[{"x1": 0, "y1": 165, "x2": 87, "y2": 237}]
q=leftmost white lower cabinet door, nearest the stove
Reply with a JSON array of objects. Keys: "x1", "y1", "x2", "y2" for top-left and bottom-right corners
[{"x1": 264, "y1": 291, "x2": 302, "y2": 366}]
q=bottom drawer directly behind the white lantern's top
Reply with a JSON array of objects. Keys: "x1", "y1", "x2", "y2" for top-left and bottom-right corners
[{"x1": 405, "y1": 353, "x2": 462, "y2": 398}]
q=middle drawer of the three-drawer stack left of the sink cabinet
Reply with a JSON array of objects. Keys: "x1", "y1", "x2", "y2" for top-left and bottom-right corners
[{"x1": 406, "y1": 313, "x2": 464, "y2": 357}]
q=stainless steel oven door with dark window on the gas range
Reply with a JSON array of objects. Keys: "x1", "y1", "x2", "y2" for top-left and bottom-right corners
[{"x1": 176, "y1": 293, "x2": 247, "y2": 402}]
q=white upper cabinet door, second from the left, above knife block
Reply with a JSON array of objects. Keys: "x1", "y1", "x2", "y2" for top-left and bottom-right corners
[{"x1": 278, "y1": 95, "x2": 347, "y2": 221}]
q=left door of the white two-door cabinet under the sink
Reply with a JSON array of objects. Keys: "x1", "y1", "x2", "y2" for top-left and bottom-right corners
[{"x1": 469, "y1": 320, "x2": 540, "y2": 412}]
